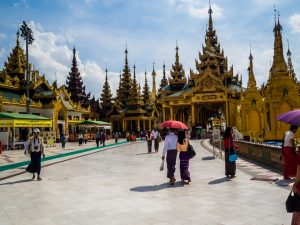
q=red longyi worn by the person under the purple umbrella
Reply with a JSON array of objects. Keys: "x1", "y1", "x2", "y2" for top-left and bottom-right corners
[{"x1": 283, "y1": 146, "x2": 300, "y2": 177}]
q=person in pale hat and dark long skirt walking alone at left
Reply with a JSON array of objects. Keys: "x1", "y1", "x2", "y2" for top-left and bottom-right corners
[{"x1": 26, "y1": 128, "x2": 45, "y2": 181}]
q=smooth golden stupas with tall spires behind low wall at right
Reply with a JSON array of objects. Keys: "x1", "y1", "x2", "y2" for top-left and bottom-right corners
[{"x1": 237, "y1": 17, "x2": 300, "y2": 140}]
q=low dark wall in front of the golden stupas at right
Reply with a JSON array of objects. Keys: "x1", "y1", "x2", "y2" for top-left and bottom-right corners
[{"x1": 234, "y1": 141, "x2": 283, "y2": 170}]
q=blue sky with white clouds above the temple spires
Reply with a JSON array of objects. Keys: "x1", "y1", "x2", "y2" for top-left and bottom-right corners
[{"x1": 0, "y1": 0, "x2": 300, "y2": 99}]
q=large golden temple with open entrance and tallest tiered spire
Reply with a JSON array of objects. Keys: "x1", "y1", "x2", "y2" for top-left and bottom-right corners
[{"x1": 158, "y1": 4, "x2": 241, "y2": 127}]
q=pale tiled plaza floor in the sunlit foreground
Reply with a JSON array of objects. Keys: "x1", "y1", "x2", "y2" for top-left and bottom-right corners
[{"x1": 0, "y1": 141, "x2": 291, "y2": 225}]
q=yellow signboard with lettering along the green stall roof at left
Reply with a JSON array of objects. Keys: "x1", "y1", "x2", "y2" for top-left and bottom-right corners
[{"x1": 0, "y1": 120, "x2": 52, "y2": 127}]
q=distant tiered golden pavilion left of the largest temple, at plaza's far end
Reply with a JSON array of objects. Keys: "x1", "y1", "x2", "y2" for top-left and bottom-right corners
[{"x1": 108, "y1": 48, "x2": 159, "y2": 132}]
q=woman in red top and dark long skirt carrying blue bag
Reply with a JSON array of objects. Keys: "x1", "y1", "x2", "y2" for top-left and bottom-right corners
[{"x1": 224, "y1": 127, "x2": 238, "y2": 178}]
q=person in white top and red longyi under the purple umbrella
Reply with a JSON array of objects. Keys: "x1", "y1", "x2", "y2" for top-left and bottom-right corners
[{"x1": 282, "y1": 125, "x2": 300, "y2": 179}]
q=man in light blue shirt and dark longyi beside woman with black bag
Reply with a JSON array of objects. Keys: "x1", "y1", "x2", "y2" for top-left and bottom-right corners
[{"x1": 162, "y1": 129, "x2": 178, "y2": 185}]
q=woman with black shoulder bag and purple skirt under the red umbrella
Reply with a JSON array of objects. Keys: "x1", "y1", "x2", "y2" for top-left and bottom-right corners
[{"x1": 176, "y1": 131, "x2": 191, "y2": 184}]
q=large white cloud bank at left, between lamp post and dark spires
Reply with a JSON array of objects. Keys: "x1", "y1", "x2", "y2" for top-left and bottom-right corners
[{"x1": 24, "y1": 22, "x2": 119, "y2": 99}]
